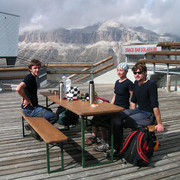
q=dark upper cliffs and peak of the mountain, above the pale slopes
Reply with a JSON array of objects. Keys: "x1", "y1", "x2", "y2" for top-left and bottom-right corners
[{"x1": 19, "y1": 21, "x2": 174, "y2": 44}]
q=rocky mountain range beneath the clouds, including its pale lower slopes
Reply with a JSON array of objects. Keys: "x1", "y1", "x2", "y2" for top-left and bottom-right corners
[{"x1": 17, "y1": 21, "x2": 180, "y2": 63}]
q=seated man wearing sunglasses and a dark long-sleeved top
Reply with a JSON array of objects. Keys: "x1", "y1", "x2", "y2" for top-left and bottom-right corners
[{"x1": 114, "y1": 63, "x2": 164, "y2": 155}]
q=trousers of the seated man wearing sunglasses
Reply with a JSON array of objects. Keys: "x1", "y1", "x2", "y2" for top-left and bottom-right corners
[{"x1": 113, "y1": 108, "x2": 155, "y2": 150}]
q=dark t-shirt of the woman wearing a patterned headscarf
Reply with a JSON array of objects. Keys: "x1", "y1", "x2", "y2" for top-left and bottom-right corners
[{"x1": 114, "y1": 79, "x2": 133, "y2": 109}]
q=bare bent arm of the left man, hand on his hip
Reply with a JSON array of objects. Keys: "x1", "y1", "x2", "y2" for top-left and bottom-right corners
[{"x1": 16, "y1": 82, "x2": 32, "y2": 107}]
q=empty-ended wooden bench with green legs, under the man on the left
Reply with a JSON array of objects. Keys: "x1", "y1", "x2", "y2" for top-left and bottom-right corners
[{"x1": 19, "y1": 110, "x2": 68, "y2": 173}]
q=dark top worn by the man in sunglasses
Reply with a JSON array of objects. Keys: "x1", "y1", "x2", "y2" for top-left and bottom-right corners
[{"x1": 131, "y1": 80, "x2": 159, "y2": 113}]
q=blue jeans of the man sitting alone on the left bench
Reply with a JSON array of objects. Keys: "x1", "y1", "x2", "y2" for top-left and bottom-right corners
[{"x1": 22, "y1": 106, "x2": 57, "y2": 124}]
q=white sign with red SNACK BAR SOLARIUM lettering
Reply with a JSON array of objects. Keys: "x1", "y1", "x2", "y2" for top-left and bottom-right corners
[{"x1": 123, "y1": 44, "x2": 161, "y2": 55}]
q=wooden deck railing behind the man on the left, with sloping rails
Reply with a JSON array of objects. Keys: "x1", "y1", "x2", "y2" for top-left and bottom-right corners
[{"x1": 0, "y1": 56, "x2": 114, "y2": 82}]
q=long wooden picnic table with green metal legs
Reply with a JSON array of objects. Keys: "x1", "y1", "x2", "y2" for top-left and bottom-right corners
[{"x1": 40, "y1": 92, "x2": 124, "y2": 167}]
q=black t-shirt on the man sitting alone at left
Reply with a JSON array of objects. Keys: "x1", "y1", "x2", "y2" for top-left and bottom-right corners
[{"x1": 23, "y1": 73, "x2": 38, "y2": 109}]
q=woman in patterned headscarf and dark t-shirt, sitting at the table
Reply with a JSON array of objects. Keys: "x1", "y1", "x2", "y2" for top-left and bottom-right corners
[{"x1": 85, "y1": 63, "x2": 133, "y2": 152}]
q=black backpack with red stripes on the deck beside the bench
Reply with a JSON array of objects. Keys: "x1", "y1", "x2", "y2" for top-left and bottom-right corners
[{"x1": 120, "y1": 128, "x2": 158, "y2": 167}]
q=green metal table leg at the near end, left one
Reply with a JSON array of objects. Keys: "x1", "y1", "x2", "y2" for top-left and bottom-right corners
[{"x1": 81, "y1": 117, "x2": 85, "y2": 168}]
